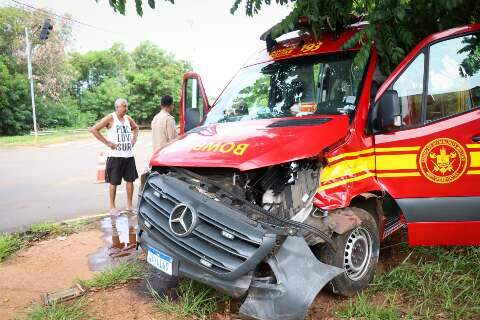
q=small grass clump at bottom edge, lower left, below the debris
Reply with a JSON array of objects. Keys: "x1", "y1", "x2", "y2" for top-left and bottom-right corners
[{"x1": 28, "y1": 299, "x2": 91, "y2": 320}]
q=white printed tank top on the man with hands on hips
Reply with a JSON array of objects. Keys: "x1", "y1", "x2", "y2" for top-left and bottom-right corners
[{"x1": 107, "y1": 112, "x2": 133, "y2": 158}]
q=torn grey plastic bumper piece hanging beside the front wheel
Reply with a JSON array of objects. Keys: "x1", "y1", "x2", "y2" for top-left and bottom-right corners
[{"x1": 240, "y1": 236, "x2": 343, "y2": 320}]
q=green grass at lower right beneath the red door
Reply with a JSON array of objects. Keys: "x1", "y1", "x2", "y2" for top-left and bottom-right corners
[{"x1": 339, "y1": 247, "x2": 480, "y2": 320}]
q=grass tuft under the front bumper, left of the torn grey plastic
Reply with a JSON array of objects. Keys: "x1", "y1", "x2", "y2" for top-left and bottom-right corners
[{"x1": 150, "y1": 280, "x2": 228, "y2": 319}]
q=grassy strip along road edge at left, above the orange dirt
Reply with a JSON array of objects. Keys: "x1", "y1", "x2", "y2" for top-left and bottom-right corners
[{"x1": 0, "y1": 219, "x2": 92, "y2": 263}]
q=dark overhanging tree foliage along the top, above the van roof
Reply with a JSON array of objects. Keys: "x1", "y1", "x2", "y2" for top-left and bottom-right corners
[{"x1": 106, "y1": 0, "x2": 480, "y2": 74}]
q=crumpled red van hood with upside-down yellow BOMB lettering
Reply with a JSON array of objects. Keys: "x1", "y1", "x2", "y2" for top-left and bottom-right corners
[{"x1": 150, "y1": 115, "x2": 349, "y2": 171}]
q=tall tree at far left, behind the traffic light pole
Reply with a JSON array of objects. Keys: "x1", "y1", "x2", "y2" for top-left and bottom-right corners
[{"x1": 0, "y1": 8, "x2": 76, "y2": 135}]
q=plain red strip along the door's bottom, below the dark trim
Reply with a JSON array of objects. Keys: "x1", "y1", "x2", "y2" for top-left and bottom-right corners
[{"x1": 408, "y1": 221, "x2": 480, "y2": 246}]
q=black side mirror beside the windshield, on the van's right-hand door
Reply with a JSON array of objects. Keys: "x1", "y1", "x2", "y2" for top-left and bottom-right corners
[{"x1": 377, "y1": 90, "x2": 402, "y2": 131}]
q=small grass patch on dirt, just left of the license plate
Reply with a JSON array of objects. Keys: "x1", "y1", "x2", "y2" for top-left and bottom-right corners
[{"x1": 78, "y1": 260, "x2": 147, "y2": 290}]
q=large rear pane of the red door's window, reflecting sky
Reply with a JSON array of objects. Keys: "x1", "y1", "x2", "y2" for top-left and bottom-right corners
[{"x1": 426, "y1": 34, "x2": 480, "y2": 121}]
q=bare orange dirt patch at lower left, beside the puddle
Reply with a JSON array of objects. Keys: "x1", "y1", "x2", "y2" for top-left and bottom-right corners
[{"x1": 0, "y1": 230, "x2": 104, "y2": 319}]
